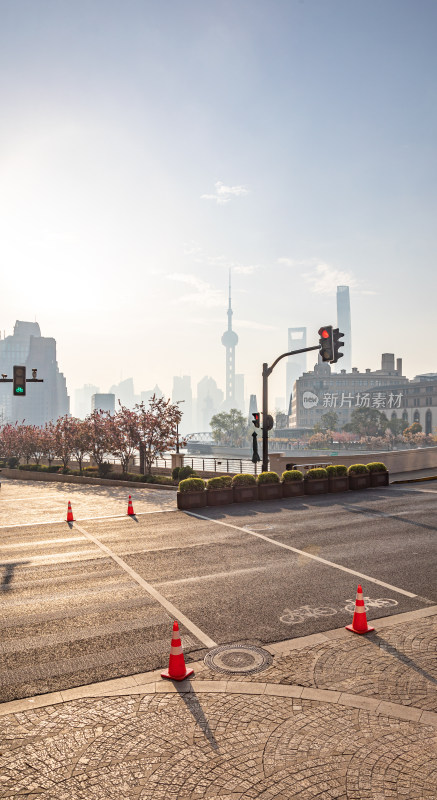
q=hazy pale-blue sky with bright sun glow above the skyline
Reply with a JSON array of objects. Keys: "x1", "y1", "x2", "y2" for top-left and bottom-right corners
[{"x1": 0, "y1": 0, "x2": 437, "y2": 406}]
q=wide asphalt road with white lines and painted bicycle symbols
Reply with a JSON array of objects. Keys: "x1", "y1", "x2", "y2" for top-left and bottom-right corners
[{"x1": 0, "y1": 482, "x2": 437, "y2": 701}]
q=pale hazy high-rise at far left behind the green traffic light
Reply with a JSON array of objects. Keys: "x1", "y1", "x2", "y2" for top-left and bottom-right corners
[{"x1": 0, "y1": 320, "x2": 70, "y2": 426}]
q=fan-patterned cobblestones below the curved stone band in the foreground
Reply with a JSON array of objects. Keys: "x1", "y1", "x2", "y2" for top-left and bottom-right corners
[{"x1": 0, "y1": 691, "x2": 437, "y2": 800}]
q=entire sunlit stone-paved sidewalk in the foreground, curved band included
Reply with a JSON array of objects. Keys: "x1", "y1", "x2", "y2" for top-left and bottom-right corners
[{"x1": 0, "y1": 606, "x2": 437, "y2": 800}]
